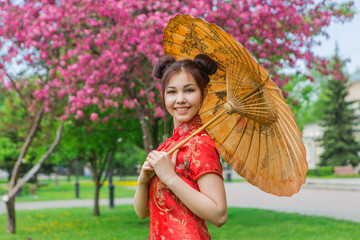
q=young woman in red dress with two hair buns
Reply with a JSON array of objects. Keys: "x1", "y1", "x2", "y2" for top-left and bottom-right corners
[{"x1": 134, "y1": 54, "x2": 227, "y2": 240}]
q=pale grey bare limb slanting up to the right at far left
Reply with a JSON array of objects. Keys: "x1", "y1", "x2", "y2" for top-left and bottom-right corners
[{"x1": 3, "y1": 121, "x2": 64, "y2": 202}]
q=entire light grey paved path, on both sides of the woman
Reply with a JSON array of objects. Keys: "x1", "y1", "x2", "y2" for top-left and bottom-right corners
[{"x1": 0, "y1": 178, "x2": 360, "y2": 223}]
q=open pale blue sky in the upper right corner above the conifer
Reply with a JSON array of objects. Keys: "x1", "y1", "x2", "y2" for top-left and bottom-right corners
[{"x1": 313, "y1": 0, "x2": 360, "y2": 74}]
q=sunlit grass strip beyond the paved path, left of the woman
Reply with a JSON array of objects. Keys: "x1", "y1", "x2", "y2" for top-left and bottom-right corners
[{"x1": 0, "y1": 180, "x2": 136, "y2": 202}]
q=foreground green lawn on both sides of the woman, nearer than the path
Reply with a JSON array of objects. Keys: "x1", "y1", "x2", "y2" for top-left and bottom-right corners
[{"x1": 0, "y1": 206, "x2": 360, "y2": 240}]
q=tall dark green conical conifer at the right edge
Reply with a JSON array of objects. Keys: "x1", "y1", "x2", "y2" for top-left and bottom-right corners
[{"x1": 320, "y1": 48, "x2": 360, "y2": 166}]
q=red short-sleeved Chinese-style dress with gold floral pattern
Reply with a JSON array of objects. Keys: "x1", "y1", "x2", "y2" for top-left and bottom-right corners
[{"x1": 149, "y1": 116, "x2": 222, "y2": 240}]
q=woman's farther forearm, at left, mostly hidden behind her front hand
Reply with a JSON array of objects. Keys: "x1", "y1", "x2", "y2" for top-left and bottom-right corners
[{"x1": 134, "y1": 161, "x2": 155, "y2": 219}]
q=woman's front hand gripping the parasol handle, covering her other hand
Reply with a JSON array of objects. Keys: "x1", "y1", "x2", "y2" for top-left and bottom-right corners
[{"x1": 146, "y1": 150, "x2": 179, "y2": 184}]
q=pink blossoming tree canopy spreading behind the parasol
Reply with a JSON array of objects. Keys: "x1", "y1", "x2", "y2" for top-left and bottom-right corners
[{"x1": 0, "y1": 0, "x2": 353, "y2": 232}]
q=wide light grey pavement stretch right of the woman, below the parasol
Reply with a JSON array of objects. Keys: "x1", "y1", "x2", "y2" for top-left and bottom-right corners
[{"x1": 226, "y1": 179, "x2": 360, "y2": 223}]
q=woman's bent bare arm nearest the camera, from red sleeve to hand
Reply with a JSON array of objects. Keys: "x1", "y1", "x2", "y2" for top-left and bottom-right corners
[{"x1": 148, "y1": 151, "x2": 227, "y2": 227}]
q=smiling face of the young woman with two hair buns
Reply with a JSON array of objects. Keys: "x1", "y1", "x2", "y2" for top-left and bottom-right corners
[{"x1": 165, "y1": 71, "x2": 201, "y2": 128}]
